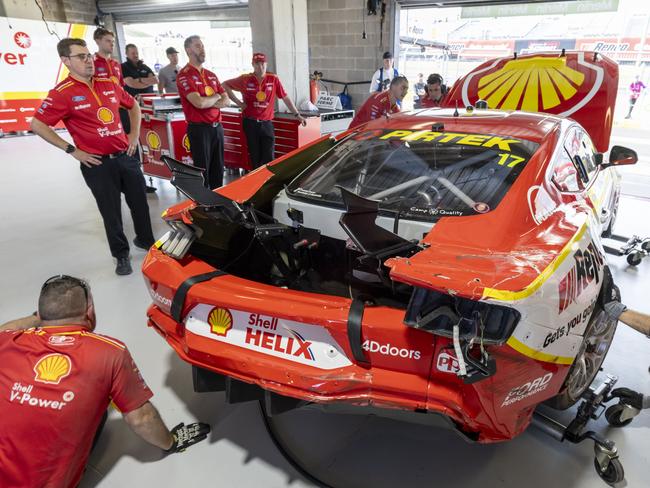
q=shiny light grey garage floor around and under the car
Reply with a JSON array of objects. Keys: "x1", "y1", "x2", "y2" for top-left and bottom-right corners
[{"x1": 0, "y1": 136, "x2": 650, "y2": 488}]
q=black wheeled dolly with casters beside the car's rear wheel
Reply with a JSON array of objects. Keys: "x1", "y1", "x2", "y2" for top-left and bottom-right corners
[{"x1": 532, "y1": 375, "x2": 639, "y2": 485}]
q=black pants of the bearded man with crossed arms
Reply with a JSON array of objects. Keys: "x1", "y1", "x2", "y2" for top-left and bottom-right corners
[{"x1": 187, "y1": 122, "x2": 223, "y2": 190}]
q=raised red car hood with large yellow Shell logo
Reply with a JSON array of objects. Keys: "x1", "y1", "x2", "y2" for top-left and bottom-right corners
[{"x1": 444, "y1": 51, "x2": 618, "y2": 152}]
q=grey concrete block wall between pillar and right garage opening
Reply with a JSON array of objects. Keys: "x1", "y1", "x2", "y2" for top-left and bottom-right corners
[{"x1": 307, "y1": 0, "x2": 395, "y2": 108}]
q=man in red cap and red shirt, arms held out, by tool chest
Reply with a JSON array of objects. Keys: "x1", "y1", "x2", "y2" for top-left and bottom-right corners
[{"x1": 223, "y1": 53, "x2": 306, "y2": 168}]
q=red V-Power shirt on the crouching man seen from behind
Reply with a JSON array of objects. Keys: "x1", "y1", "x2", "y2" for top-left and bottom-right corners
[{"x1": 0, "y1": 326, "x2": 153, "y2": 488}]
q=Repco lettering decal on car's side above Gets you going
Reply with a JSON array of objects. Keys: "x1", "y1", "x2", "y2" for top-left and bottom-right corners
[{"x1": 558, "y1": 242, "x2": 605, "y2": 313}]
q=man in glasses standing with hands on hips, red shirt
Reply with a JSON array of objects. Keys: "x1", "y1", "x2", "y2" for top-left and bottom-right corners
[{"x1": 31, "y1": 38, "x2": 154, "y2": 275}]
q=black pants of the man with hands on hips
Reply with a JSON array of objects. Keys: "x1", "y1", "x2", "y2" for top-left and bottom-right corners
[{"x1": 81, "y1": 153, "x2": 154, "y2": 258}]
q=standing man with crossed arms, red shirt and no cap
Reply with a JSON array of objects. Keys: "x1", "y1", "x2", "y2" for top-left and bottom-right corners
[{"x1": 176, "y1": 36, "x2": 230, "y2": 189}]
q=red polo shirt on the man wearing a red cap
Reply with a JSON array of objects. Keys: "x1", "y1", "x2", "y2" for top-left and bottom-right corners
[{"x1": 226, "y1": 73, "x2": 287, "y2": 120}]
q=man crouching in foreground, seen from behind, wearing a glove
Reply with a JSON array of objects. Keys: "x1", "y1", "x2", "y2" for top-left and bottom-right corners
[{"x1": 0, "y1": 275, "x2": 210, "y2": 487}]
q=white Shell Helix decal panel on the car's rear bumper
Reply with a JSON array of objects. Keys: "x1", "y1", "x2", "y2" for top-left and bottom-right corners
[{"x1": 185, "y1": 304, "x2": 352, "y2": 370}]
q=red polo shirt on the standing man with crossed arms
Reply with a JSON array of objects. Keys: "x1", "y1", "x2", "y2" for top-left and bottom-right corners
[{"x1": 176, "y1": 64, "x2": 226, "y2": 124}]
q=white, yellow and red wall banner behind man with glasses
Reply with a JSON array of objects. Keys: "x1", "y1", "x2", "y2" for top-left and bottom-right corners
[{"x1": 0, "y1": 17, "x2": 95, "y2": 132}]
